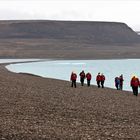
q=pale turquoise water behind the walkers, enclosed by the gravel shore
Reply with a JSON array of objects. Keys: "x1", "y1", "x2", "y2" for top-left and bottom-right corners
[{"x1": 6, "y1": 59, "x2": 140, "y2": 91}]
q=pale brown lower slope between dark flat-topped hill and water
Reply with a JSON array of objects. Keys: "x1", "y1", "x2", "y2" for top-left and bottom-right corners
[{"x1": 0, "y1": 39, "x2": 140, "y2": 59}]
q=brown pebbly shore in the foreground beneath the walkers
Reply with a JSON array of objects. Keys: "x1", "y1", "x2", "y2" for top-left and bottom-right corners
[{"x1": 0, "y1": 64, "x2": 140, "y2": 140}]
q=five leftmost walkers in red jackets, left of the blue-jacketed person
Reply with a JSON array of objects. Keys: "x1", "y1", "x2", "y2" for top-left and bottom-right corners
[{"x1": 70, "y1": 70, "x2": 105, "y2": 88}]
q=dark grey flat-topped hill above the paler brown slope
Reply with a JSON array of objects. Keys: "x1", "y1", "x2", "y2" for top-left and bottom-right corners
[{"x1": 0, "y1": 20, "x2": 140, "y2": 44}]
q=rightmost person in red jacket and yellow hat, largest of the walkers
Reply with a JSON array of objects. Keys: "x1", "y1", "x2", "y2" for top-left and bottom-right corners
[{"x1": 130, "y1": 76, "x2": 140, "y2": 96}]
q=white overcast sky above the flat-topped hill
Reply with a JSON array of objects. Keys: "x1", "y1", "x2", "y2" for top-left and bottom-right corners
[{"x1": 0, "y1": 0, "x2": 140, "y2": 30}]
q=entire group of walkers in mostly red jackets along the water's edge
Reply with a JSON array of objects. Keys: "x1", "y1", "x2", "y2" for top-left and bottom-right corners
[{"x1": 70, "y1": 70, "x2": 140, "y2": 96}]
